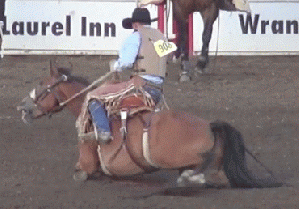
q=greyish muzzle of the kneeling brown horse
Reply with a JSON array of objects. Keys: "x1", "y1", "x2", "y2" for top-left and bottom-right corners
[{"x1": 17, "y1": 97, "x2": 42, "y2": 124}]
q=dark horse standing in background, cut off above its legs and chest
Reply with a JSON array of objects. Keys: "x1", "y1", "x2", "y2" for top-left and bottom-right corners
[{"x1": 139, "y1": 0, "x2": 250, "y2": 78}]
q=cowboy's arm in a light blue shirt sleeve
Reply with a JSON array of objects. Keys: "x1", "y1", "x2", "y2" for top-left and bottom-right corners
[{"x1": 114, "y1": 32, "x2": 140, "y2": 71}]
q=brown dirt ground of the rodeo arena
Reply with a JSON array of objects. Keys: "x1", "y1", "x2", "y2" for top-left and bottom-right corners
[{"x1": 0, "y1": 56, "x2": 299, "y2": 209}]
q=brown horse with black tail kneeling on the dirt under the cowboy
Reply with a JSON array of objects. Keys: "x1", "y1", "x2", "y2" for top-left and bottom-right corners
[{"x1": 19, "y1": 62, "x2": 268, "y2": 188}]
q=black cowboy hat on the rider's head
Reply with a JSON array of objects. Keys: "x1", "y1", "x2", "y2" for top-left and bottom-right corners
[{"x1": 122, "y1": 8, "x2": 152, "y2": 29}]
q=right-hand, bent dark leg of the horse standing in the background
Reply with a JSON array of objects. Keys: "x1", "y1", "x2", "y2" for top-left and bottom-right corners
[{"x1": 195, "y1": 4, "x2": 219, "y2": 73}]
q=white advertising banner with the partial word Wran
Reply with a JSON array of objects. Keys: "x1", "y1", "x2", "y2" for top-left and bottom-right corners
[{"x1": 193, "y1": 1, "x2": 299, "y2": 55}]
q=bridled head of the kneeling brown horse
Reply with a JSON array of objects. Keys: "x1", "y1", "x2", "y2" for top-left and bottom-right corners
[{"x1": 18, "y1": 63, "x2": 70, "y2": 123}]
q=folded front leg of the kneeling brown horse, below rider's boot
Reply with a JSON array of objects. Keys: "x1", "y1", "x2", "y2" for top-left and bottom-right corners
[{"x1": 77, "y1": 140, "x2": 100, "y2": 174}]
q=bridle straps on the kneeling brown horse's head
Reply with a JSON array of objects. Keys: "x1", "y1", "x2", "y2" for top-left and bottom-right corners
[{"x1": 29, "y1": 75, "x2": 68, "y2": 117}]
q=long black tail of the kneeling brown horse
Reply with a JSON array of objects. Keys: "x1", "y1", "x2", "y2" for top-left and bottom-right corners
[{"x1": 211, "y1": 122, "x2": 263, "y2": 188}]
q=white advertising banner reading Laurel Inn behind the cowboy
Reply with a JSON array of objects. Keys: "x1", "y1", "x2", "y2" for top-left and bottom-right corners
[{"x1": 4, "y1": 0, "x2": 157, "y2": 55}]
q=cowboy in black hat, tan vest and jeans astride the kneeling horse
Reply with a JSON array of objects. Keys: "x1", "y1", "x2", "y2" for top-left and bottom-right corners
[{"x1": 88, "y1": 8, "x2": 167, "y2": 142}]
